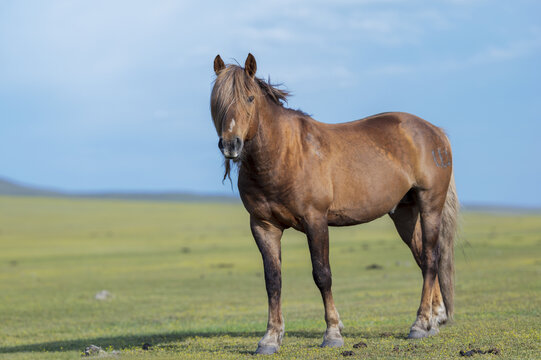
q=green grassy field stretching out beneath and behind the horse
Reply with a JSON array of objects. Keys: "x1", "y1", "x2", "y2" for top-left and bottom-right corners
[{"x1": 0, "y1": 197, "x2": 541, "y2": 359}]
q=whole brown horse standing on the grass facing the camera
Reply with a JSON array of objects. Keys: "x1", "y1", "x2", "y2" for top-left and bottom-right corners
[{"x1": 210, "y1": 54, "x2": 458, "y2": 354}]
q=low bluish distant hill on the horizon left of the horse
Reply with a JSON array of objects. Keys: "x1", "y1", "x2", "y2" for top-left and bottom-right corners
[{"x1": 0, "y1": 178, "x2": 240, "y2": 203}]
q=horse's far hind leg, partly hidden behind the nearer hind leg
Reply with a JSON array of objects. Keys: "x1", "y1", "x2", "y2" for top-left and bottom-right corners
[{"x1": 389, "y1": 193, "x2": 447, "y2": 335}]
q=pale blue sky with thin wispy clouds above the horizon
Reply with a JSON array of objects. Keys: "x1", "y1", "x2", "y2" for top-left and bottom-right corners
[{"x1": 0, "y1": 0, "x2": 541, "y2": 207}]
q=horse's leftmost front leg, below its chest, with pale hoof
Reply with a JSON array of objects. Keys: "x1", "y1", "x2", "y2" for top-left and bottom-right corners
[{"x1": 250, "y1": 217, "x2": 284, "y2": 354}]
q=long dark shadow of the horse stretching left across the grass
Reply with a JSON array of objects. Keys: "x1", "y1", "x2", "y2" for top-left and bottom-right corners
[{"x1": 0, "y1": 330, "x2": 404, "y2": 354}]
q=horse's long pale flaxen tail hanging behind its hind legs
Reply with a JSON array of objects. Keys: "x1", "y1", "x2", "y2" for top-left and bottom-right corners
[{"x1": 438, "y1": 174, "x2": 460, "y2": 320}]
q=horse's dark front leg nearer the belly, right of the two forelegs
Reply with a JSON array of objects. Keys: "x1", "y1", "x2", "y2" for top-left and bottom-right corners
[{"x1": 305, "y1": 216, "x2": 344, "y2": 347}]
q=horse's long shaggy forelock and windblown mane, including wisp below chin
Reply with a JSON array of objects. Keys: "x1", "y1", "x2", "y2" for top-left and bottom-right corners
[{"x1": 210, "y1": 64, "x2": 290, "y2": 180}]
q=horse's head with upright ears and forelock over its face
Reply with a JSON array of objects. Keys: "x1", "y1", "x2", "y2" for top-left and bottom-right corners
[{"x1": 210, "y1": 54, "x2": 262, "y2": 160}]
